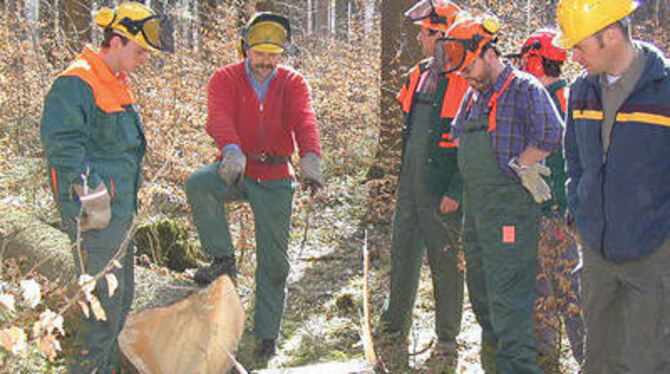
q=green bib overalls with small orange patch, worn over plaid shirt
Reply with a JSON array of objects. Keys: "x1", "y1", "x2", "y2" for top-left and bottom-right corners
[{"x1": 458, "y1": 119, "x2": 541, "y2": 374}]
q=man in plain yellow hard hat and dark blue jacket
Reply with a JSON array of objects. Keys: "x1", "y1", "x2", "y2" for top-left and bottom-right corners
[{"x1": 555, "y1": 0, "x2": 670, "y2": 374}]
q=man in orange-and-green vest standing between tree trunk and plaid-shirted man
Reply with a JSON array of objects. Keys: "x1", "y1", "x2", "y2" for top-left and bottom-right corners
[{"x1": 379, "y1": 0, "x2": 468, "y2": 373}]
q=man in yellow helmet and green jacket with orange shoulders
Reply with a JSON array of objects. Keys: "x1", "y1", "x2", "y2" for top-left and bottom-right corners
[{"x1": 40, "y1": 3, "x2": 169, "y2": 373}]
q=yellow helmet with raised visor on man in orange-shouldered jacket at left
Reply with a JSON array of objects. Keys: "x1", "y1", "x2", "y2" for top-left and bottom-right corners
[{"x1": 95, "y1": 2, "x2": 172, "y2": 51}]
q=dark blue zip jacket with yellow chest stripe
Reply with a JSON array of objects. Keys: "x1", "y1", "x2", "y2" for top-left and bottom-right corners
[{"x1": 565, "y1": 42, "x2": 670, "y2": 263}]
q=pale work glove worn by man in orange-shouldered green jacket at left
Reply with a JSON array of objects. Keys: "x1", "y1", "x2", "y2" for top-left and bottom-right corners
[{"x1": 73, "y1": 183, "x2": 112, "y2": 232}]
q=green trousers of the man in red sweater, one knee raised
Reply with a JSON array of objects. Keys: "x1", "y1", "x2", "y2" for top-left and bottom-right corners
[{"x1": 186, "y1": 163, "x2": 295, "y2": 339}]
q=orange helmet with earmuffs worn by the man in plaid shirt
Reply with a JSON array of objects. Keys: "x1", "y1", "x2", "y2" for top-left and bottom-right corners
[{"x1": 438, "y1": 16, "x2": 500, "y2": 74}]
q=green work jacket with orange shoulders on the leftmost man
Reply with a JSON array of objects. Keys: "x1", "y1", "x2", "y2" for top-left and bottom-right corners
[{"x1": 40, "y1": 47, "x2": 146, "y2": 220}]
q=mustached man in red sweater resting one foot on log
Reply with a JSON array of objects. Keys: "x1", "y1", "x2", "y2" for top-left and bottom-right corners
[{"x1": 186, "y1": 12, "x2": 323, "y2": 366}]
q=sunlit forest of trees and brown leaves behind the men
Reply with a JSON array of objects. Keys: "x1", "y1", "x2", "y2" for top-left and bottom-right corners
[{"x1": 0, "y1": 0, "x2": 670, "y2": 373}]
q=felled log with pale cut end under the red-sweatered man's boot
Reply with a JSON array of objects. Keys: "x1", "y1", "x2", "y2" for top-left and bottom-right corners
[{"x1": 0, "y1": 206, "x2": 244, "y2": 374}]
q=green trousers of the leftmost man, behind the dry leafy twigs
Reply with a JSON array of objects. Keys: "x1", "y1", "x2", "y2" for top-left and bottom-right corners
[{"x1": 63, "y1": 217, "x2": 134, "y2": 374}]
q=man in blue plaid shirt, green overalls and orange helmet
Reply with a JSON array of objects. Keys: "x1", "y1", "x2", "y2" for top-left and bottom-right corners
[{"x1": 442, "y1": 17, "x2": 562, "y2": 374}]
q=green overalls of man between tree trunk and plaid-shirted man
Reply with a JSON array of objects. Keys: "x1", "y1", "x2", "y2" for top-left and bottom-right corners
[{"x1": 381, "y1": 97, "x2": 463, "y2": 349}]
